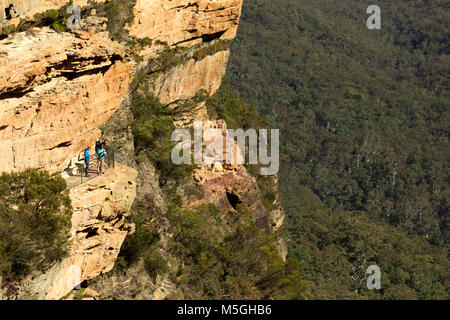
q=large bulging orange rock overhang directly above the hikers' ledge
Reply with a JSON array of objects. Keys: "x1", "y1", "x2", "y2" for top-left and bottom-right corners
[{"x1": 0, "y1": 28, "x2": 130, "y2": 172}]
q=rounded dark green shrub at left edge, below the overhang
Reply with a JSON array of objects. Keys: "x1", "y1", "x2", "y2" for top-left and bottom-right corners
[{"x1": 0, "y1": 169, "x2": 72, "y2": 283}]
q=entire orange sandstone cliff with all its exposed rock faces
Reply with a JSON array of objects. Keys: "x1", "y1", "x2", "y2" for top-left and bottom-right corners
[{"x1": 0, "y1": 0, "x2": 283, "y2": 299}]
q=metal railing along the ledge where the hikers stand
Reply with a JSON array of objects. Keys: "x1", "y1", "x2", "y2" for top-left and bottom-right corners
[{"x1": 66, "y1": 148, "x2": 116, "y2": 189}]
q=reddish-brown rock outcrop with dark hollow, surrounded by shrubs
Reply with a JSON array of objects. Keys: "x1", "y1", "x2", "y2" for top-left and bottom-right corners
[{"x1": 188, "y1": 120, "x2": 285, "y2": 232}]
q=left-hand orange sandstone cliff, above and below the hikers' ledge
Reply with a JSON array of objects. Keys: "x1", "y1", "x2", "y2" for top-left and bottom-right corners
[{"x1": 0, "y1": 1, "x2": 137, "y2": 299}]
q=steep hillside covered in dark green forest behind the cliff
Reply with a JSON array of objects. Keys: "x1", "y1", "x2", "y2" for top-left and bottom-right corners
[{"x1": 227, "y1": 0, "x2": 450, "y2": 299}]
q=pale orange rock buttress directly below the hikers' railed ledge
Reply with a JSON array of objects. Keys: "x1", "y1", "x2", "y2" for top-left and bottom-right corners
[{"x1": 18, "y1": 164, "x2": 137, "y2": 299}]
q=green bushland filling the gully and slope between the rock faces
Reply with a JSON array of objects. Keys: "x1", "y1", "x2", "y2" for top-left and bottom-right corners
[{"x1": 109, "y1": 74, "x2": 308, "y2": 299}]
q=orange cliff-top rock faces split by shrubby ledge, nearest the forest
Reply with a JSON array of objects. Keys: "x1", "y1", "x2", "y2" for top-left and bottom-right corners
[{"x1": 128, "y1": 0, "x2": 242, "y2": 107}]
